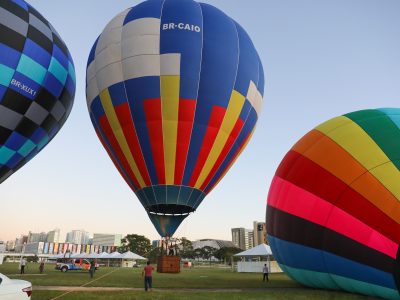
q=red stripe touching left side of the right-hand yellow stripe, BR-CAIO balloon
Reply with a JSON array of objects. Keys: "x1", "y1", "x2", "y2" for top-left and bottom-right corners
[{"x1": 189, "y1": 106, "x2": 226, "y2": 186}]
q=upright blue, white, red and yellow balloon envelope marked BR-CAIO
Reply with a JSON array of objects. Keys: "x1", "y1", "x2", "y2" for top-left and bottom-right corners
[{"x1": 86, "y1": 0, "x2": 264, "y2": 237}]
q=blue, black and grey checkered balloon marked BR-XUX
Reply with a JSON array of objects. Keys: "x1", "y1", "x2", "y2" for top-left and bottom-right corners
[{"x1": 0, "y1": 0, "x2": 75, "y2": 183}]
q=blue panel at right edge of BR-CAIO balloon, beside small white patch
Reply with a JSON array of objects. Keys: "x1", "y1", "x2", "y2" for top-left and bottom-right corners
[{"x1": 235, "y1": 23, "x2": 259, "y2": 97}]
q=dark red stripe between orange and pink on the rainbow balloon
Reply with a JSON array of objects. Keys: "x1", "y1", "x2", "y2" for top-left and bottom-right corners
[{"x1": 275, "y1": 151, "x2": 400, "y2": 243}]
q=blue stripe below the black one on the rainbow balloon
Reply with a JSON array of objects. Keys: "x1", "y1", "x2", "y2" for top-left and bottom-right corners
[{"x1": 268, "y1": 235, "x2": 396, "y2": 289}]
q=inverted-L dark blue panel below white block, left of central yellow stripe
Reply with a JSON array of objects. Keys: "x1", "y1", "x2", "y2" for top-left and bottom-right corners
[{"x1": 125, "y1": 76, "x2": 160, "y2": 185}]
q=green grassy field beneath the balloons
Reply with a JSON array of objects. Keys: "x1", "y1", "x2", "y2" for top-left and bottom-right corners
[{"x1": 0, "y1": 263, "x2": 372, "y2": 300}]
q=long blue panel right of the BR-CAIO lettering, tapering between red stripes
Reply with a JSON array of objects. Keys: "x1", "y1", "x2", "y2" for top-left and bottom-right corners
[{"x1": 183, "y1": 3, "x2": 239, "y2": 185}]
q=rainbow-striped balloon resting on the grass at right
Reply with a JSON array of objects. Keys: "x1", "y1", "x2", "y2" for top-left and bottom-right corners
[{"x1": 266, "y1": 109, "x2": 400, "y2": 299}]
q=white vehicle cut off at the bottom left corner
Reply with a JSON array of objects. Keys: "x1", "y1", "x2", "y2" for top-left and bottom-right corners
[{"x1": 0, "y1": 273, "x2": 32, "y2": 300}]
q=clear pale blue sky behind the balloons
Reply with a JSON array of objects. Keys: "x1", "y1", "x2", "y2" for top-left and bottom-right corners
[{"x1": 0, "y1": 0, "x2": 400, "y2": 240}]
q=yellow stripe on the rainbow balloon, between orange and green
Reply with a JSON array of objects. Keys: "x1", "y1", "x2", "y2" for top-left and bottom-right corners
[{"x1": 316, "y1": 116, "x2": 400, "y2": 199}]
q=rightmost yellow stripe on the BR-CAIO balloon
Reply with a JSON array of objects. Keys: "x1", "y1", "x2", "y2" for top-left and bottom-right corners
[{"x1": 195, "y1": 90, "x2": 246, "y2": 188}]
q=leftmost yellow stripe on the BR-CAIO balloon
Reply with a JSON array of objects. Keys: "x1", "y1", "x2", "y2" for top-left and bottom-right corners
[{"x1": 99, "y1": 89, "x2": 145, "y2": 188}]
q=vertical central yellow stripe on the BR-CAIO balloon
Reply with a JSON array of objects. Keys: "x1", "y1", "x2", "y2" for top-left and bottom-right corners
[{"x1": 161, "y1": 75, "x2": 180, "y2": 184}]
